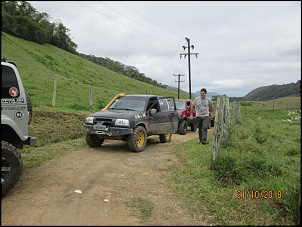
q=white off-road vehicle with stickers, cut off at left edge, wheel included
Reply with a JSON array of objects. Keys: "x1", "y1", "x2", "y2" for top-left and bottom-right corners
[{"x1": 1, "y1": 59, "x2": 37, "y2": 197}]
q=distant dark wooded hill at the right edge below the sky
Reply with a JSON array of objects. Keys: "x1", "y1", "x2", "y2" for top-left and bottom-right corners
[{"x1": 243, "y1": 80, "x2": 301, "y2": 101}]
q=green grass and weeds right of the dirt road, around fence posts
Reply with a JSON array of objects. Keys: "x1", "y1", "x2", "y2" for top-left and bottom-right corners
[{"x1": 168, "y1": 102, "x2": 301, "y2": 226}]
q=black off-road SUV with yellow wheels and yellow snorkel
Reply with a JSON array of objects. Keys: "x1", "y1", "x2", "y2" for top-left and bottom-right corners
[{"x1": 84, "y1": 94, "x2": 179, "y2": 152}]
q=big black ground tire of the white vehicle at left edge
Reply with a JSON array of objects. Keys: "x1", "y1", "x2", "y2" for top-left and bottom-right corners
[{"x1": 1, "y1": 140, "x2": 23, "y2": 197}]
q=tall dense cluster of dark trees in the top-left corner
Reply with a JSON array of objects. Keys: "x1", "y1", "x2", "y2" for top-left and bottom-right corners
[{"x1": 1, "y1": 1, "x2": 77, "y2": 54}]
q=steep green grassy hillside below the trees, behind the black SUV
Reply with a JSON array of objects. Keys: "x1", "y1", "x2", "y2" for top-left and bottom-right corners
[{"x1": 1, "y1": 32, "x2": 188, "y2": 111}]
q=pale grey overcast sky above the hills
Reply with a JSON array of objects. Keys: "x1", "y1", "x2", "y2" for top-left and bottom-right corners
[{"x1": 29, "y1": 1, "x2": 301, "y2": 97}]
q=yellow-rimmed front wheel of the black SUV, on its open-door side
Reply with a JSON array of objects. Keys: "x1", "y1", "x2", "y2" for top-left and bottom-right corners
[{"x1": 128, "y1": 126, "x2": 147, "y2": 152}]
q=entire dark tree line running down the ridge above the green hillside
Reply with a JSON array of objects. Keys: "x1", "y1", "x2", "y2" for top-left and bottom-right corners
[{"x1": 1, "y1": 1, "x2": 166, "y2": 88}]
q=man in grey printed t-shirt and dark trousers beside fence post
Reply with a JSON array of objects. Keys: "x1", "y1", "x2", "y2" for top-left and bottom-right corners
[{"x1": 190, "y1": 88, "x2": 213, "y2": 144}]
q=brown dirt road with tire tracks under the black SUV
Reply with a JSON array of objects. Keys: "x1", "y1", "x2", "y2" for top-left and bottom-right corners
[{"x1": 1, "y1": 131, "x2": 210, "y2": 226}]
